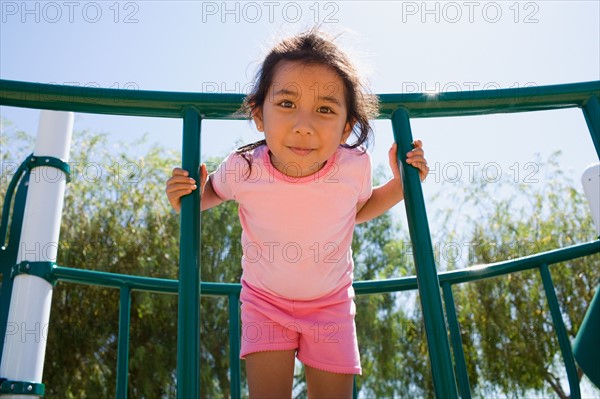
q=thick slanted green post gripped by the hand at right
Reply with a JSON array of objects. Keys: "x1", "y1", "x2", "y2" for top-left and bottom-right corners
[{"x1": 392, "y1": 108, "x2": 458, "y2": 399}]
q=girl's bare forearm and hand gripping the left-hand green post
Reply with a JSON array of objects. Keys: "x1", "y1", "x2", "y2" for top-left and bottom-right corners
[{"x1": 165, "y1": 164, "x2": 223, "y2": 213}]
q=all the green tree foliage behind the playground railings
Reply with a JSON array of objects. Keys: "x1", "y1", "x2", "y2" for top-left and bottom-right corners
[{"x1": 0, "y1": 120, "x2": 600, "y2": 398}]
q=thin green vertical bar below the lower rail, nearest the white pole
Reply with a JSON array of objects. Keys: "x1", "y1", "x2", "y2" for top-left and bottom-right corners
[{"x1": 116, "y1": 286, "x2": 131, "y2": 399}]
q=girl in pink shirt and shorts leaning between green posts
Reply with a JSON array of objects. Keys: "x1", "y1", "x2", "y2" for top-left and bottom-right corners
[{"x1": 166, "y1": 29, "x2": 429, "y2": 398}]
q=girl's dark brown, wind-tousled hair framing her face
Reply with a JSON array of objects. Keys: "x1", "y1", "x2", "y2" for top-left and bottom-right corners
[{"x1": 236, "y1": 27, "x2": 379, "y2": 167}]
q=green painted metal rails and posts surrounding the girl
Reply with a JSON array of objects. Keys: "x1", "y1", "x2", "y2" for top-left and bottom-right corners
[{"x1": 0, "y1": 80, "x2": 600, "y2": 399}]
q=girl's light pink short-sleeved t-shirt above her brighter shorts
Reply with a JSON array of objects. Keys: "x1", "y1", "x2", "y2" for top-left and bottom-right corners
[{"x1": 211, "y1": 145, "x2": 372, "y2": 300}]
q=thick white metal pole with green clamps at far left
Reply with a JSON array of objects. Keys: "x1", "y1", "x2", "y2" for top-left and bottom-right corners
[{"x1": 0, "y1": 110, "x2": 74, "y2": 398}]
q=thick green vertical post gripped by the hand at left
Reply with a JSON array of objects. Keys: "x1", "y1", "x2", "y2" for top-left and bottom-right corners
[{"x1": 177, "y1": 107, "x2": 201, "y2": 399}]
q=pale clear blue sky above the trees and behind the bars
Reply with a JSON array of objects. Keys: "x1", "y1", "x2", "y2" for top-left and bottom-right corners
[{"x1": 0, "y1": 0, "x2": 600, "y2": 238}]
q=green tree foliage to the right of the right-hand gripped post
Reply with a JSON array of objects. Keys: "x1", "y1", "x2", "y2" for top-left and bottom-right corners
[{"x1": 436, "y1": 154, "x2": 600, "y2": 398}]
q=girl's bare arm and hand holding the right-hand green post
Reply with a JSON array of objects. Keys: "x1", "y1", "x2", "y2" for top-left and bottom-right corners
[{"x1": 356, "y1": 140, "x2": 429, "y2": 224}]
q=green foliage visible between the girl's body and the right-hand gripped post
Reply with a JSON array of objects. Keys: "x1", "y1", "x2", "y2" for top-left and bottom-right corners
[{"x1": 352, "y1": 169, "x2": 433, "y2": 398}]
